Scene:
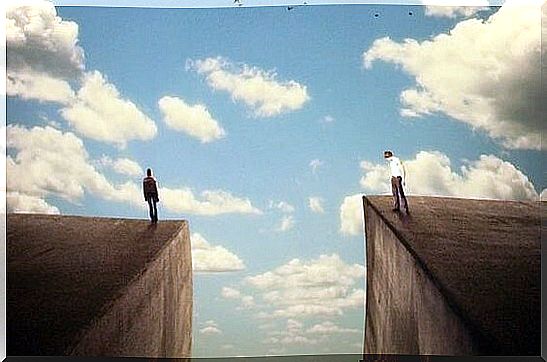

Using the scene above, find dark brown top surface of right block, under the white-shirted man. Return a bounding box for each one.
[363,196,547,354]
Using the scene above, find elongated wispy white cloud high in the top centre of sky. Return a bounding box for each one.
[187,57,310,117]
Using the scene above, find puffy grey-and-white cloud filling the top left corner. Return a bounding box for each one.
[6,0,84,103]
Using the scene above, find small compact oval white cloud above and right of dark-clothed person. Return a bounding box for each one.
[158,96,226,143]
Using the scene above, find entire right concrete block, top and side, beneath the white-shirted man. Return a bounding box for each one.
[363,196,545,355]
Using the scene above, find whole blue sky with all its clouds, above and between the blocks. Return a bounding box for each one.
[5,0,547,357]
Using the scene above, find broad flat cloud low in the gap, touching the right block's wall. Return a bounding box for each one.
[246,254,365,318]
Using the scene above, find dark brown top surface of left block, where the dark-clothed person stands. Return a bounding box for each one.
[6,214,190,355]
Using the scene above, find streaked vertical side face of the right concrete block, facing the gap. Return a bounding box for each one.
[364,202,478,355]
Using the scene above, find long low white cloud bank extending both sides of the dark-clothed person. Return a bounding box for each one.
[6,125,261,216]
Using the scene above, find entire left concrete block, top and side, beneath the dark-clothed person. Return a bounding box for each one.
[7,214,192,357]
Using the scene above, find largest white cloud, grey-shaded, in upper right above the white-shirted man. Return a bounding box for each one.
[363,3,547,149]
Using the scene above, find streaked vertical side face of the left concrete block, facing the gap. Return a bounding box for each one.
[66,223,193,358]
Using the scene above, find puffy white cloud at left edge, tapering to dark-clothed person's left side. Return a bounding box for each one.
[6,125,142,212]
